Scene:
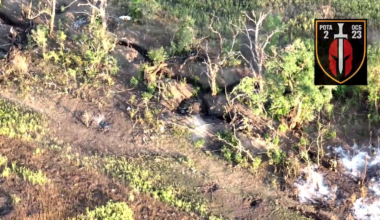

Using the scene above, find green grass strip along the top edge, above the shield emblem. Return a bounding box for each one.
[127,0,380,42]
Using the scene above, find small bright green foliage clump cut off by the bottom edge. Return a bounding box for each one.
[74,201,133,220]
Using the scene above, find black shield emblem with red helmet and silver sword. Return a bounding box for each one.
[315,19,367,85]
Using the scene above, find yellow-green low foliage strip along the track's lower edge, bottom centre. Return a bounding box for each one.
[92,157,207,215]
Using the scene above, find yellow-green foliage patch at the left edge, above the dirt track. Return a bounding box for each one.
[0,99,46,140]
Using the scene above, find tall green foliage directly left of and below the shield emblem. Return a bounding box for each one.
[266,39,336,121]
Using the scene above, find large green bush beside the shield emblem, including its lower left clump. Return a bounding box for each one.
[232,39,336,124]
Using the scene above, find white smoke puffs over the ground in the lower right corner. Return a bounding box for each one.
[295,145,380,220]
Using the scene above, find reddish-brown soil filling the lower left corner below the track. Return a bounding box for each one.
[0,136,196,219]
